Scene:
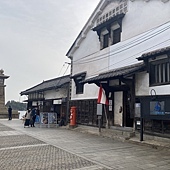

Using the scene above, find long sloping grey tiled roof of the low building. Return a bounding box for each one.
[21,75,70,95]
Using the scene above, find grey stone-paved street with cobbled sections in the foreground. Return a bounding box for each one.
[0,120,170,170]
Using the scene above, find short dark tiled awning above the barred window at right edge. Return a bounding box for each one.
[137,46,170,60]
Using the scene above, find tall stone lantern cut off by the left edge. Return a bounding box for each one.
[0,69,9,118]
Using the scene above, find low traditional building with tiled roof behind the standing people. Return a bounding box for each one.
[20,75,70,122]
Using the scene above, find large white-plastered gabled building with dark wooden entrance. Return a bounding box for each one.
[67,0,170,131]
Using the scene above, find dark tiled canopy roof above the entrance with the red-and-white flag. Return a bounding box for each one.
[81,63,145,83]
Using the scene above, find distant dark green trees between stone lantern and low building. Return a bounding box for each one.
[5,100,27,111]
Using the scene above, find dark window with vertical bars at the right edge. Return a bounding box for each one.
[149,59,170,85]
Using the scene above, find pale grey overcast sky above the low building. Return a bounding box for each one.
[0,0,99,102]
